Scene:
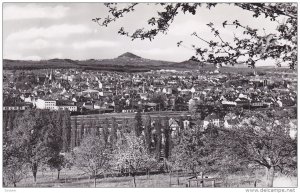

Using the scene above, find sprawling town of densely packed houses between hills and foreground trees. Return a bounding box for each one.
[3,63,297,146]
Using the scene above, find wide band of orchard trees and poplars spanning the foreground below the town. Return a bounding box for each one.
[3,110,297,187]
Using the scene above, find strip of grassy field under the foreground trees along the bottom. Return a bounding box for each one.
[10,168,297,188]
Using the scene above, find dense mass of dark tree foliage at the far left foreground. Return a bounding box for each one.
[3,110,70,183]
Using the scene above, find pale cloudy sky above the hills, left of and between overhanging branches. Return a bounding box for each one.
[3,3,276,62]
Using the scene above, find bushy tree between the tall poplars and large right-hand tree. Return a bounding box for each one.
[170,127,223,174]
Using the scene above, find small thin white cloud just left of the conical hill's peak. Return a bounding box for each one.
[72,40,119,49]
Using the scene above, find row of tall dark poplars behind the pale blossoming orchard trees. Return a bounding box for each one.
[71,111,180,160]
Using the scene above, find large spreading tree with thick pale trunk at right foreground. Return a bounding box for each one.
[223,111,297,187]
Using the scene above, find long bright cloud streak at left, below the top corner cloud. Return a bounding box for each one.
[7,24,92,41]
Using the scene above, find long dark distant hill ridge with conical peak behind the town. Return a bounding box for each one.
[3,52,272,72]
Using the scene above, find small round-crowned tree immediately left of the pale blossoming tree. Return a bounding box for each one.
[74,135,111,187]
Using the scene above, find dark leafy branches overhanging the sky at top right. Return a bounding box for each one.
[92,3,298,69]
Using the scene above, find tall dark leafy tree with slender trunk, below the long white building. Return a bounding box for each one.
[11,110,54,182]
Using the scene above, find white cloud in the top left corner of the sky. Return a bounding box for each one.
[3,4,70,20]
